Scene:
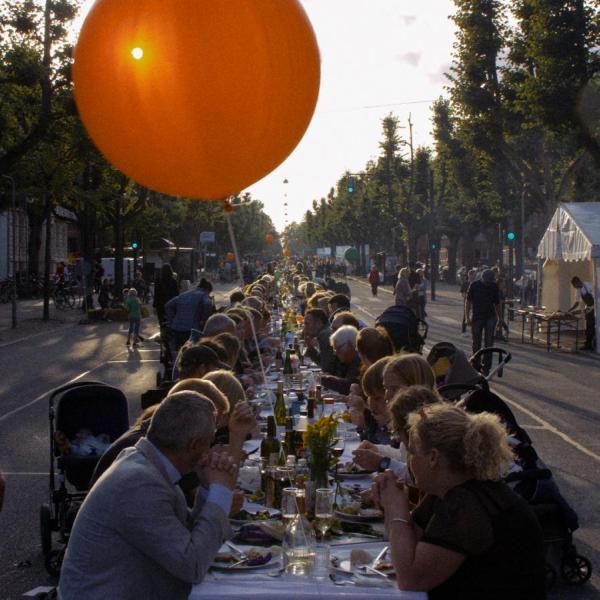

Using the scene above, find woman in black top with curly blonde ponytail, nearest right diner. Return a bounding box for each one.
[374,403,546,600]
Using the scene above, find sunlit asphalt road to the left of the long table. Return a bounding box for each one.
[0,292,232,600]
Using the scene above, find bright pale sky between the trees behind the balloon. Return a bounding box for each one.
[77,0,455,231]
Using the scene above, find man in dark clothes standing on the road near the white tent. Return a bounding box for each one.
[465,269,502,375]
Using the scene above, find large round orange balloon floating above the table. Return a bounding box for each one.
[73,0,320,199]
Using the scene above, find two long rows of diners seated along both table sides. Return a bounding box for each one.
[59,262,546,600]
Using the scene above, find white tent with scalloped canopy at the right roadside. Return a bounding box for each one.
[537,202,600,352]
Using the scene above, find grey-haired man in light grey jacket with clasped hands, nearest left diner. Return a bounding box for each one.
[58,392,237,600]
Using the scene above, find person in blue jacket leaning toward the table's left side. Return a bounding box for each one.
[165,278,214,351]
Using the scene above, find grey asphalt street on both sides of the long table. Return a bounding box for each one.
[0,282,600,600]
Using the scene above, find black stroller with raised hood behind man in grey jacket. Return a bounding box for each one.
[40,381,129,577]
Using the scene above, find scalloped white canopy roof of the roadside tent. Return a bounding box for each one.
[537,202,600,261]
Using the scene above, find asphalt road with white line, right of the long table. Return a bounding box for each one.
[351,281,600,600]
